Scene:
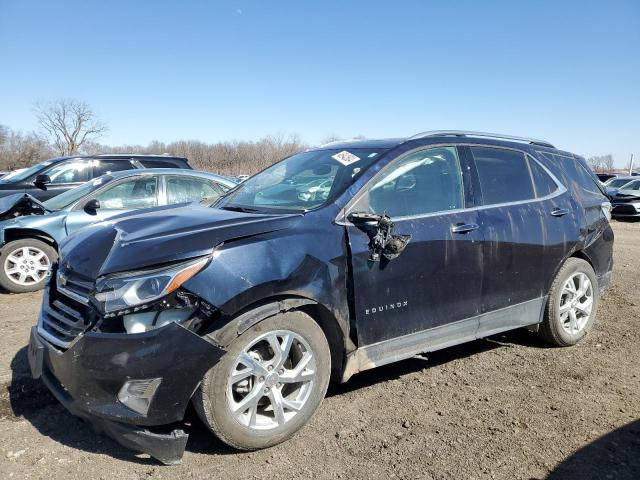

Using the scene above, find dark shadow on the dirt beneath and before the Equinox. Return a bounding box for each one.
[5,332,543,465]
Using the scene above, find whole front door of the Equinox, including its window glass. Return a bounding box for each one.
[346,147,482,346]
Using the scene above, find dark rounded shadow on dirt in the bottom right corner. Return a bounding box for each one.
[547,420,640,480]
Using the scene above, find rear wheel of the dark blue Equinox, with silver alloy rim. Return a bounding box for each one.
[538,257,599,347]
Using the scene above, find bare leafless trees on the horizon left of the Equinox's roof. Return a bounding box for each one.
[0,99,307,175]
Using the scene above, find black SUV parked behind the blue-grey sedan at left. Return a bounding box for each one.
[0,154,191,201]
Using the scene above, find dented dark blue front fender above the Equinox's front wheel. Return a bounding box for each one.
[183,226,349,338]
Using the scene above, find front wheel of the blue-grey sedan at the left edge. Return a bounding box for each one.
[0,238,58,293]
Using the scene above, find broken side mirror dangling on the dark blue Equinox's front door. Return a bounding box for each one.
[347,212,411,262]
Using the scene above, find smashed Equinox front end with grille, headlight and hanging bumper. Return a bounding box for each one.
[29,258,224,464]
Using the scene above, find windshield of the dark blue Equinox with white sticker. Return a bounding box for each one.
[215,148,387,212]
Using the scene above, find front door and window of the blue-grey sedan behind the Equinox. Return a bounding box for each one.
[66,175,159,235]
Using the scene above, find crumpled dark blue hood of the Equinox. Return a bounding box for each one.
[60,204,301,280]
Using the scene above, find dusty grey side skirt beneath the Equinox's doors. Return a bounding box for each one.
[342,296,547,382]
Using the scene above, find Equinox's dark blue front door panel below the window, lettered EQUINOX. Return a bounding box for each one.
[347,211,482,346]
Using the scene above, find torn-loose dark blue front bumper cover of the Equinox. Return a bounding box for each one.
[29,323,224,464]
